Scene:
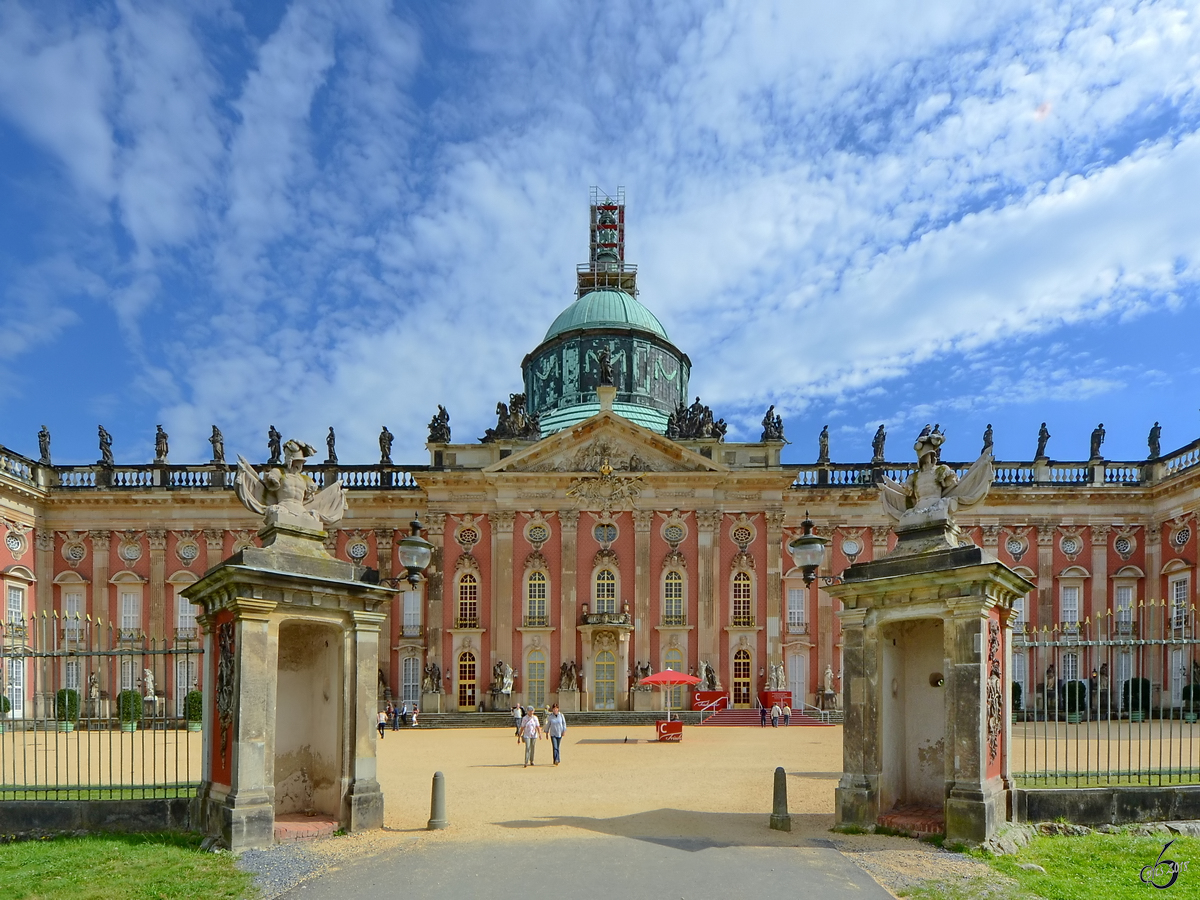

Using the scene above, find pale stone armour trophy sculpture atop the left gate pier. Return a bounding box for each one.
[234,440,346,532]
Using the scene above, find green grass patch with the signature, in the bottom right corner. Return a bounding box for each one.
[906,833,1200,900]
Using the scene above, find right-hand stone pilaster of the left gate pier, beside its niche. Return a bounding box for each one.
[342,610,385,832]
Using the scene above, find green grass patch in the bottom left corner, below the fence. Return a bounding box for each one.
[0,834,257,900]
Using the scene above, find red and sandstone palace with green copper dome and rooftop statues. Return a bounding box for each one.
[0,192,1200,718]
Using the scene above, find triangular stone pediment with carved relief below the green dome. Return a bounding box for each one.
[484,409,730,474]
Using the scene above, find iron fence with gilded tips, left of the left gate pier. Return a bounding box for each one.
[0,612,203,800]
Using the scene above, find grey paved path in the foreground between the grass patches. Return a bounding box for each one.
[283,836,893,900]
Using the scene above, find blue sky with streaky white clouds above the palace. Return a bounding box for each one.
[0,0,1200,463]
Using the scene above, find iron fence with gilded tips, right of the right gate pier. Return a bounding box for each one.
[1012,601,1200,787]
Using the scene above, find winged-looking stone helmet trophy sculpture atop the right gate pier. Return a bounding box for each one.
[880,425,995,533]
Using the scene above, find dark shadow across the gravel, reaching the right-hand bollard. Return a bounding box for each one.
[496,809,833,852]
